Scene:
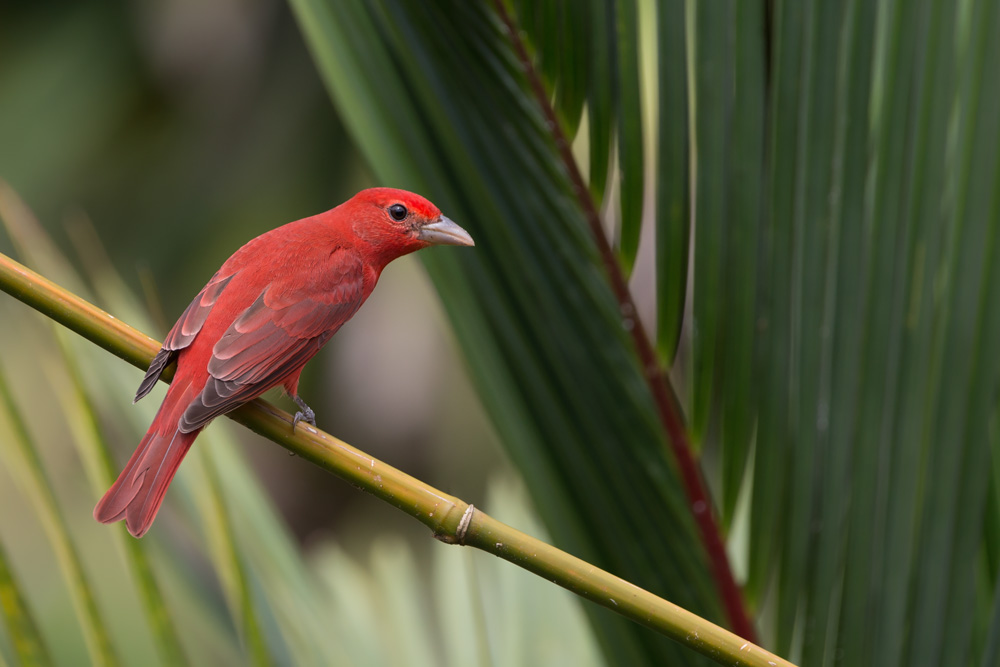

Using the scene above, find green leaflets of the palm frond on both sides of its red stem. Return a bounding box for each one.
[293,0,1000,664]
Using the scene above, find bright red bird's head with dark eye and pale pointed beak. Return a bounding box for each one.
[338,188,475,263]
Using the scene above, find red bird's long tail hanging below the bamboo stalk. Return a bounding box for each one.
[94,381,201,537]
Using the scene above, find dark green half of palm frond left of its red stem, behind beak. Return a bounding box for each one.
[295,2,736,664]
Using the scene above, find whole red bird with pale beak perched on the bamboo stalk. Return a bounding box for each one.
[94,188,474,537]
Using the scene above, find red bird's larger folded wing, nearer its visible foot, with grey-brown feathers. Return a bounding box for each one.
[178,250,364,432]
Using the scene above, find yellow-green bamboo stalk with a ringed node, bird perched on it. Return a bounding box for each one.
[0,254,792,667]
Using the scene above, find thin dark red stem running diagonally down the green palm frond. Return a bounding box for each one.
[493,0,757,643]
